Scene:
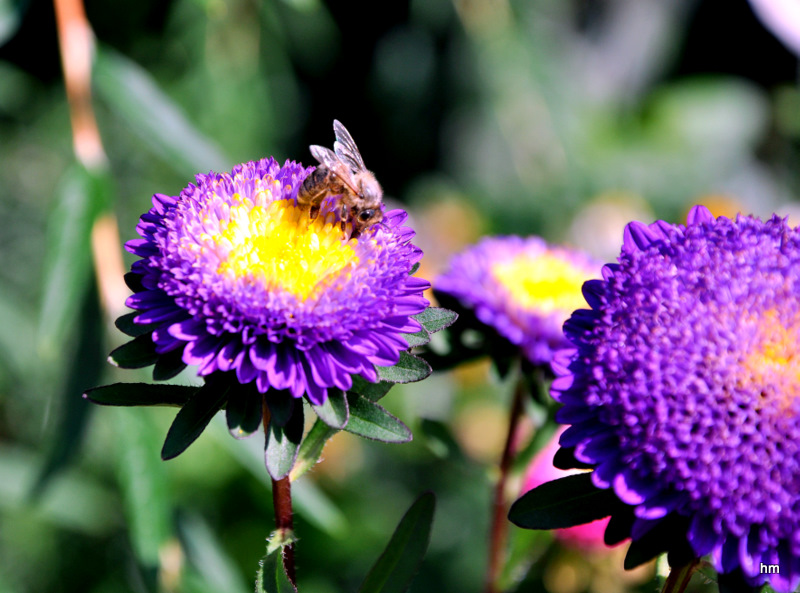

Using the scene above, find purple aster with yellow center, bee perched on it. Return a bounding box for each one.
[126,158,430,404]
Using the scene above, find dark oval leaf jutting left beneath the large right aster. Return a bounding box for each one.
[508,473,620,529]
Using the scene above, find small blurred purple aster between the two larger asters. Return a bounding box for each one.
[435,236,600,364]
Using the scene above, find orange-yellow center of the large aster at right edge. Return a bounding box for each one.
[743,310,800,411]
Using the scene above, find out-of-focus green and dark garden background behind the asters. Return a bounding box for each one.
[0,0,800,593]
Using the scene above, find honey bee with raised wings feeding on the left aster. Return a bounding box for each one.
[297,120,383,238]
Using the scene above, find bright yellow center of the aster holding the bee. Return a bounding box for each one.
[211,200,358,300]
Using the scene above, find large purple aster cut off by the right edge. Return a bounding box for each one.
[552,206,800,591]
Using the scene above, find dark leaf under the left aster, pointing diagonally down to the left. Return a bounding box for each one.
[161,377,228,460]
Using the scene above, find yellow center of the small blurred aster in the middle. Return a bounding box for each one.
[492,253,589,313]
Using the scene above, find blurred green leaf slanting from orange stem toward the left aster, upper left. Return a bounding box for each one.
[93,46,229,174]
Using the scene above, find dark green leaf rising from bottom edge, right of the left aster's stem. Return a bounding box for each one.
[358,492,436,593]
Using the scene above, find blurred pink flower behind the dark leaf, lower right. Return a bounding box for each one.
[520,427,609,551]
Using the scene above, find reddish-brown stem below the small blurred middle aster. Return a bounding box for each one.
[485,370,526,593]
